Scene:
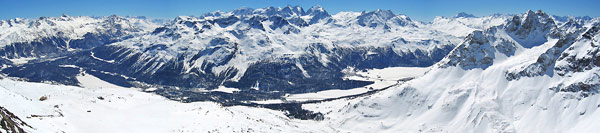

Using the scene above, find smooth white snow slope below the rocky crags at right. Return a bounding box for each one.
[303,67,600,132]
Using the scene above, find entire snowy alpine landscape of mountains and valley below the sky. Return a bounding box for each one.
[0,6,600,132]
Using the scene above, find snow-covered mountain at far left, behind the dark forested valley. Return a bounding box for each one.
[0,14,158,65]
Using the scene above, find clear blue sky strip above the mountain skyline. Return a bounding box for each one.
[0,0,600,21]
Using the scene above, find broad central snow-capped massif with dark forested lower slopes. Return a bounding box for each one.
[3,6,468,103]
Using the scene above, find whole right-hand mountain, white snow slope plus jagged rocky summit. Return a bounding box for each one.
[304,11,600,132]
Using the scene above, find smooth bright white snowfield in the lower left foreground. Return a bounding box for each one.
[0,79,328,132]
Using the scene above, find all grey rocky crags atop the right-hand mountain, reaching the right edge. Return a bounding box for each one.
[437,11,600,97]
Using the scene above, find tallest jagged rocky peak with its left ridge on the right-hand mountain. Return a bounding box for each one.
[440,10,560,69]
